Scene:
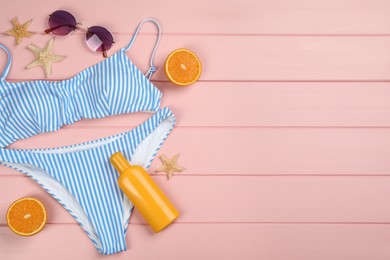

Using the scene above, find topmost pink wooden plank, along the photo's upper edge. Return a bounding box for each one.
[0,0,390,34]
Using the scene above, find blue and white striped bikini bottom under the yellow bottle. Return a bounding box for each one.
[0,108,176,254]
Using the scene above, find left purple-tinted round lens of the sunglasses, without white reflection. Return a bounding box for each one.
[49,10,76,36]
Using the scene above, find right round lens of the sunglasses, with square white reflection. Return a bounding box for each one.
[85,26,114,52]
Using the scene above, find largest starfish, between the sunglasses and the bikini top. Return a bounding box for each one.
[26,38,65,77]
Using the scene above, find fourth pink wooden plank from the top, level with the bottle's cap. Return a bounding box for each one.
[1,127,390,175]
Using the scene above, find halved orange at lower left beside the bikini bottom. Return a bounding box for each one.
[7,198,46,236]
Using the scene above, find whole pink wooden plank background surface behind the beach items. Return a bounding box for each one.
[0,0,390,260]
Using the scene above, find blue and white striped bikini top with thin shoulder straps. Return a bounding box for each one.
[0,18,162,147]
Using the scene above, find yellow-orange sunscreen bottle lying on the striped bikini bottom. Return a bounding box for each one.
[110,152,180,232]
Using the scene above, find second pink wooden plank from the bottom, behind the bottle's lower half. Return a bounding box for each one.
[0,174,390,224]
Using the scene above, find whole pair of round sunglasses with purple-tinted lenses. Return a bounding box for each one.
[45,10,114,58]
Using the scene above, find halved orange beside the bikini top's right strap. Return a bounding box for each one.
[165,48,202,86]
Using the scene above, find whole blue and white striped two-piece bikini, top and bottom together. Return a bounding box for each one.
[0,18,175,254]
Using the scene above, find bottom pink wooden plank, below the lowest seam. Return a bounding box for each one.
[0,224,390,260]
